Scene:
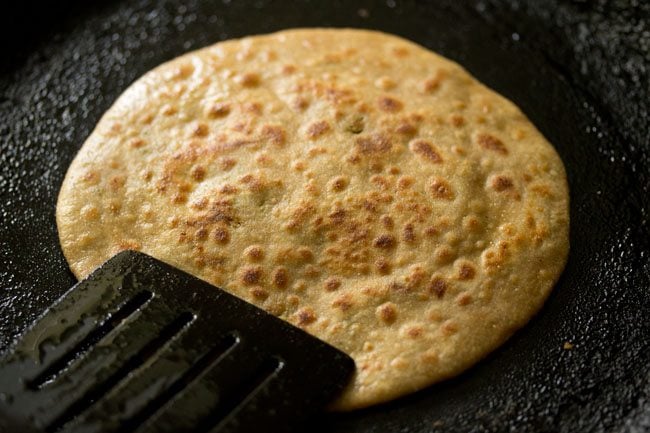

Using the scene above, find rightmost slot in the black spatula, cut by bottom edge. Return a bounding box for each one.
[196,357,284,433]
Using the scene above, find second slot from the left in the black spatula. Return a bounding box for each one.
[45,312,195,433]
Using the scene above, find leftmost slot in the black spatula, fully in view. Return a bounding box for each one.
[26,291,153,391]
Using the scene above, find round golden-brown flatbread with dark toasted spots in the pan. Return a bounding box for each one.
[57,29,569,410]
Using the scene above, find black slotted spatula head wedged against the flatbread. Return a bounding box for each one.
[0,251,354,433]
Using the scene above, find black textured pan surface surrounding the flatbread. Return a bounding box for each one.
[0,0,650,433]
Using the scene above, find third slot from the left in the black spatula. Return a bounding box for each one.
[121,332,240,432]
